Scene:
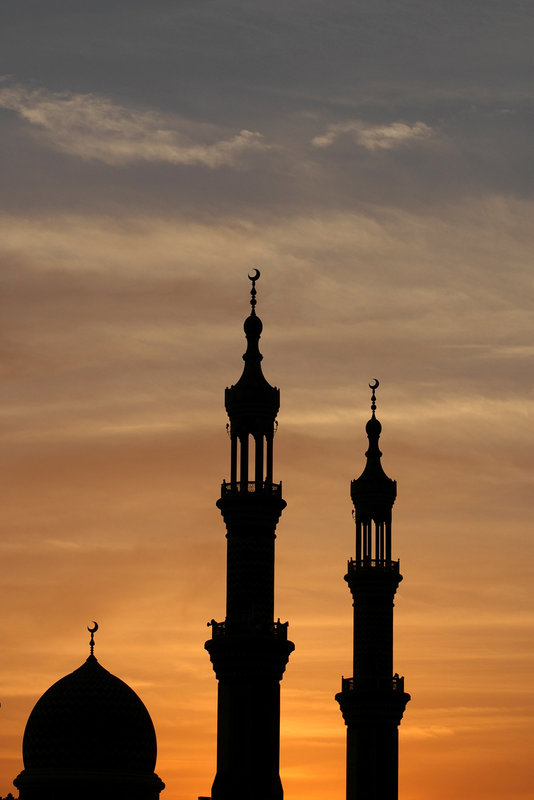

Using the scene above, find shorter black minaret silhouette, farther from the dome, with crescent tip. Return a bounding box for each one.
[336,379,410,800]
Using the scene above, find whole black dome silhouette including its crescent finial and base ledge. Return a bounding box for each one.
[13,626,165,800]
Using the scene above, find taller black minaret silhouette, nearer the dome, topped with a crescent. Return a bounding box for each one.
[206,270,294,800]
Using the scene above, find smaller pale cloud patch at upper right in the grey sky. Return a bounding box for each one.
[312,120,433,150]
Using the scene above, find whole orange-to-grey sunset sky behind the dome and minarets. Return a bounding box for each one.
[0,0,534,800]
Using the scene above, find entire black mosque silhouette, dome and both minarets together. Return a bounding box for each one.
[0,270,410,800]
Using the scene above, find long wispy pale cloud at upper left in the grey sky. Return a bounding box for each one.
[0,85,267,169]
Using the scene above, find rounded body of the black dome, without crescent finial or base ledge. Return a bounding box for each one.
[22,655,157,774]
